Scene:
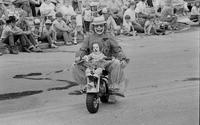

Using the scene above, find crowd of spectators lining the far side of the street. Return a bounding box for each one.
[0,0,200,54]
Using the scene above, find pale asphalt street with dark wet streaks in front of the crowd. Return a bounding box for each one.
[0,27,200,125]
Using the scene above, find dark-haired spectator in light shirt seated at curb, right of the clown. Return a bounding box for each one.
[123,15,136,36]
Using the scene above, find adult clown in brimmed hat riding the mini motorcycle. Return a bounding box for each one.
[72,16,128,102]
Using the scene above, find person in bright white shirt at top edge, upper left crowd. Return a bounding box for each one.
[40,0,55,19]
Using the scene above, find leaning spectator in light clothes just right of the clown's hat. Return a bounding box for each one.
[102,8,121,35]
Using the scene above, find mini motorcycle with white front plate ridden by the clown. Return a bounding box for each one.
[75,58,121,113]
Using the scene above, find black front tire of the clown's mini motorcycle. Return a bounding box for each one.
[86,94,99,113]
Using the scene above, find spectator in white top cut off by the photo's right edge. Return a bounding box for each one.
[190,1,200,23]
